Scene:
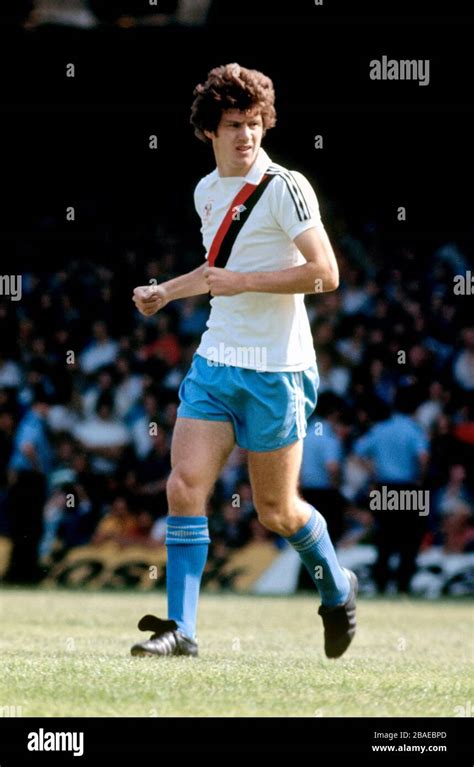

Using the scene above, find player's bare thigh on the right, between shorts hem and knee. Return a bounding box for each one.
[248,439,303,508]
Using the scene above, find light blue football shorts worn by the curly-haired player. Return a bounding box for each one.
[178,354,319,452]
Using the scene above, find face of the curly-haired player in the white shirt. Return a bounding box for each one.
[205,109,263,176]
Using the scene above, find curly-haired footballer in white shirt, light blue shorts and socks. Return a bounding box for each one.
[131,63,357,658]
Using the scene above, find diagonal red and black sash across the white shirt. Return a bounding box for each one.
[207,173,275,268]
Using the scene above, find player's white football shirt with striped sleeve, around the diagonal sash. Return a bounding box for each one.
[194,148,323,372]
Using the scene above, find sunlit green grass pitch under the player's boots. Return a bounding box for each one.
[0,589,473,717]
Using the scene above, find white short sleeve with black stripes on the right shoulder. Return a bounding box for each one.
[271,170,322,240]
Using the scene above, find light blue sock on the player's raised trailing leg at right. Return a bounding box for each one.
[286,506,350,607]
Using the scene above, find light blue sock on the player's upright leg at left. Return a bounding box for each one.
[166,517,211,639]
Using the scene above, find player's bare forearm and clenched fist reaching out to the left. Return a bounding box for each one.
[133,262,209,317]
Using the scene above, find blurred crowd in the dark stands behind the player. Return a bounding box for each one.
[0,234,474,590]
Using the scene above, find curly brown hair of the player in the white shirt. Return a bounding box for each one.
[191,64,276,144]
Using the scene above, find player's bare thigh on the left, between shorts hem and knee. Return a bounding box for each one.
[171,418,235,494]
